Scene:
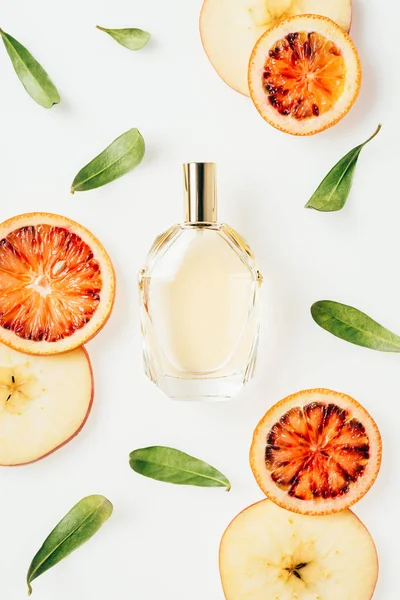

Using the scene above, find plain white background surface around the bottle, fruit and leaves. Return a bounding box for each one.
[0,0,400,600]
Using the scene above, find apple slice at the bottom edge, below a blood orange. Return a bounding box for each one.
[220,500,378,600]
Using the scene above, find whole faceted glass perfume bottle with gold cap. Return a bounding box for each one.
[139,163,262,400]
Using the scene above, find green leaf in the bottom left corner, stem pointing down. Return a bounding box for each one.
[26,495,113,595]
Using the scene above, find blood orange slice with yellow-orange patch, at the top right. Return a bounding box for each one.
[249,15,361,135]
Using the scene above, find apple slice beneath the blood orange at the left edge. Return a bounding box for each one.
[0,344,93,466]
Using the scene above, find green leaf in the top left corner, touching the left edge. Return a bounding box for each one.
[0,29,60,108]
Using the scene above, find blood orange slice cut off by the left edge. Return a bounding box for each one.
[0,213,115,354]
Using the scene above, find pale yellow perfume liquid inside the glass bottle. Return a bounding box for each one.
[150,228,254,374]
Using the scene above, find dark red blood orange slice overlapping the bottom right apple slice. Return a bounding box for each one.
[250,389,382,515]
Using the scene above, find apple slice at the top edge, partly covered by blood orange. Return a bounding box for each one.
[200,0,351,96]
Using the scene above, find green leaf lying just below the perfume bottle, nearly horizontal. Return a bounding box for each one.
[129,446,231,491]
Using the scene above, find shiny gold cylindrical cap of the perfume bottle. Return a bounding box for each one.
[183,163,217,223]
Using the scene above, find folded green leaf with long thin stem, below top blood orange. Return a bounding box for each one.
[305,125,382,212]
